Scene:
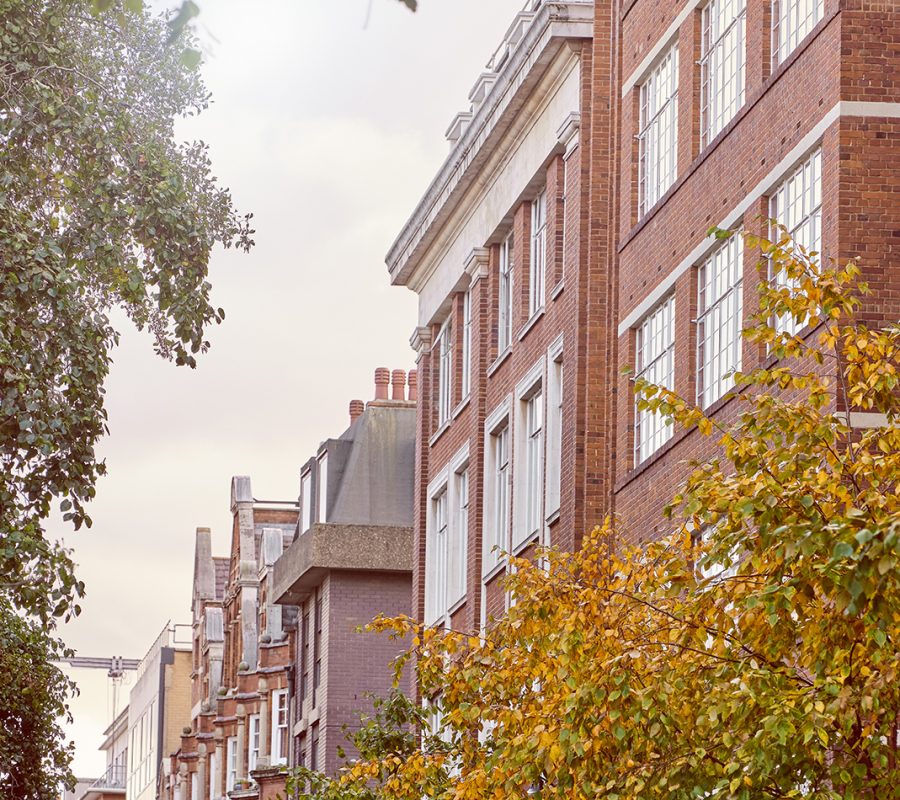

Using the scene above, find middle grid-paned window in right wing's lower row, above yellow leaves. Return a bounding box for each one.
[697,236,744,408]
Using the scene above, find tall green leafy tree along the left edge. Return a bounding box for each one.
[0,0,253,800]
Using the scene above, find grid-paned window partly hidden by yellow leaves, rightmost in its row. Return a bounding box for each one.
[769,149,822,334]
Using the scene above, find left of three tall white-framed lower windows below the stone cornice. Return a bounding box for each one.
[481,397,512,577]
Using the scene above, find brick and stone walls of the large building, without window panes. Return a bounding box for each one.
[387,0,900,631]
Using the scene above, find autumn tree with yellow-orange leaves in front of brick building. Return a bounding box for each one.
[306,232,900,800]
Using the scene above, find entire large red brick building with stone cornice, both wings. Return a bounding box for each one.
[387,0,900,630]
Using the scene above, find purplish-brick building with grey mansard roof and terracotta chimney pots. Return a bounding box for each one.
[270,368,416,775]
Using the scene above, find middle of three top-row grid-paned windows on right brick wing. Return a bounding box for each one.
[700,0,747,145]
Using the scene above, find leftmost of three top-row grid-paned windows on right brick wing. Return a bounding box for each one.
[638,42,678,216]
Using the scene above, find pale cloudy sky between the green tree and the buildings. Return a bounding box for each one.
[59,0,523,776]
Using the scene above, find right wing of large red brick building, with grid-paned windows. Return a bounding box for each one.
[611,0,900,540]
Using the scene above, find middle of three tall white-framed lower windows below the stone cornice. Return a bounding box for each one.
[512,356,545,553]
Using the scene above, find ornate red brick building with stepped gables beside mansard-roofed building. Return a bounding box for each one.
[163,476,299,800]
